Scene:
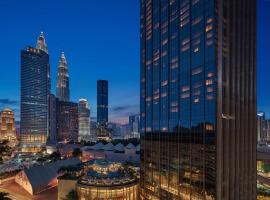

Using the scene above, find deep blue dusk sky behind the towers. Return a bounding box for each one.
[0,0,270,122]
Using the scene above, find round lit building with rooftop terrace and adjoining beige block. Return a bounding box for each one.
[58,160,139,200]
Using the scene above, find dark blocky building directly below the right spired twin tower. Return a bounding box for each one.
[56,100,79,141]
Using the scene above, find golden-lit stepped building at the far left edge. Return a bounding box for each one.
[0,108,17,146]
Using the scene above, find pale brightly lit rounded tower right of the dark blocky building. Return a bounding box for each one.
[78,99,91,141]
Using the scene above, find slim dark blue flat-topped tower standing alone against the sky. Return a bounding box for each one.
[97,80,108,124]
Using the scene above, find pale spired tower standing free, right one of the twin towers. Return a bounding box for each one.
[56,52,70,101]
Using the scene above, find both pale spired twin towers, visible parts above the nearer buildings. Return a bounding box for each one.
[36,32,70,101]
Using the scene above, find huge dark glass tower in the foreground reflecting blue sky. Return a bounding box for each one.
[140,0,257,200]
